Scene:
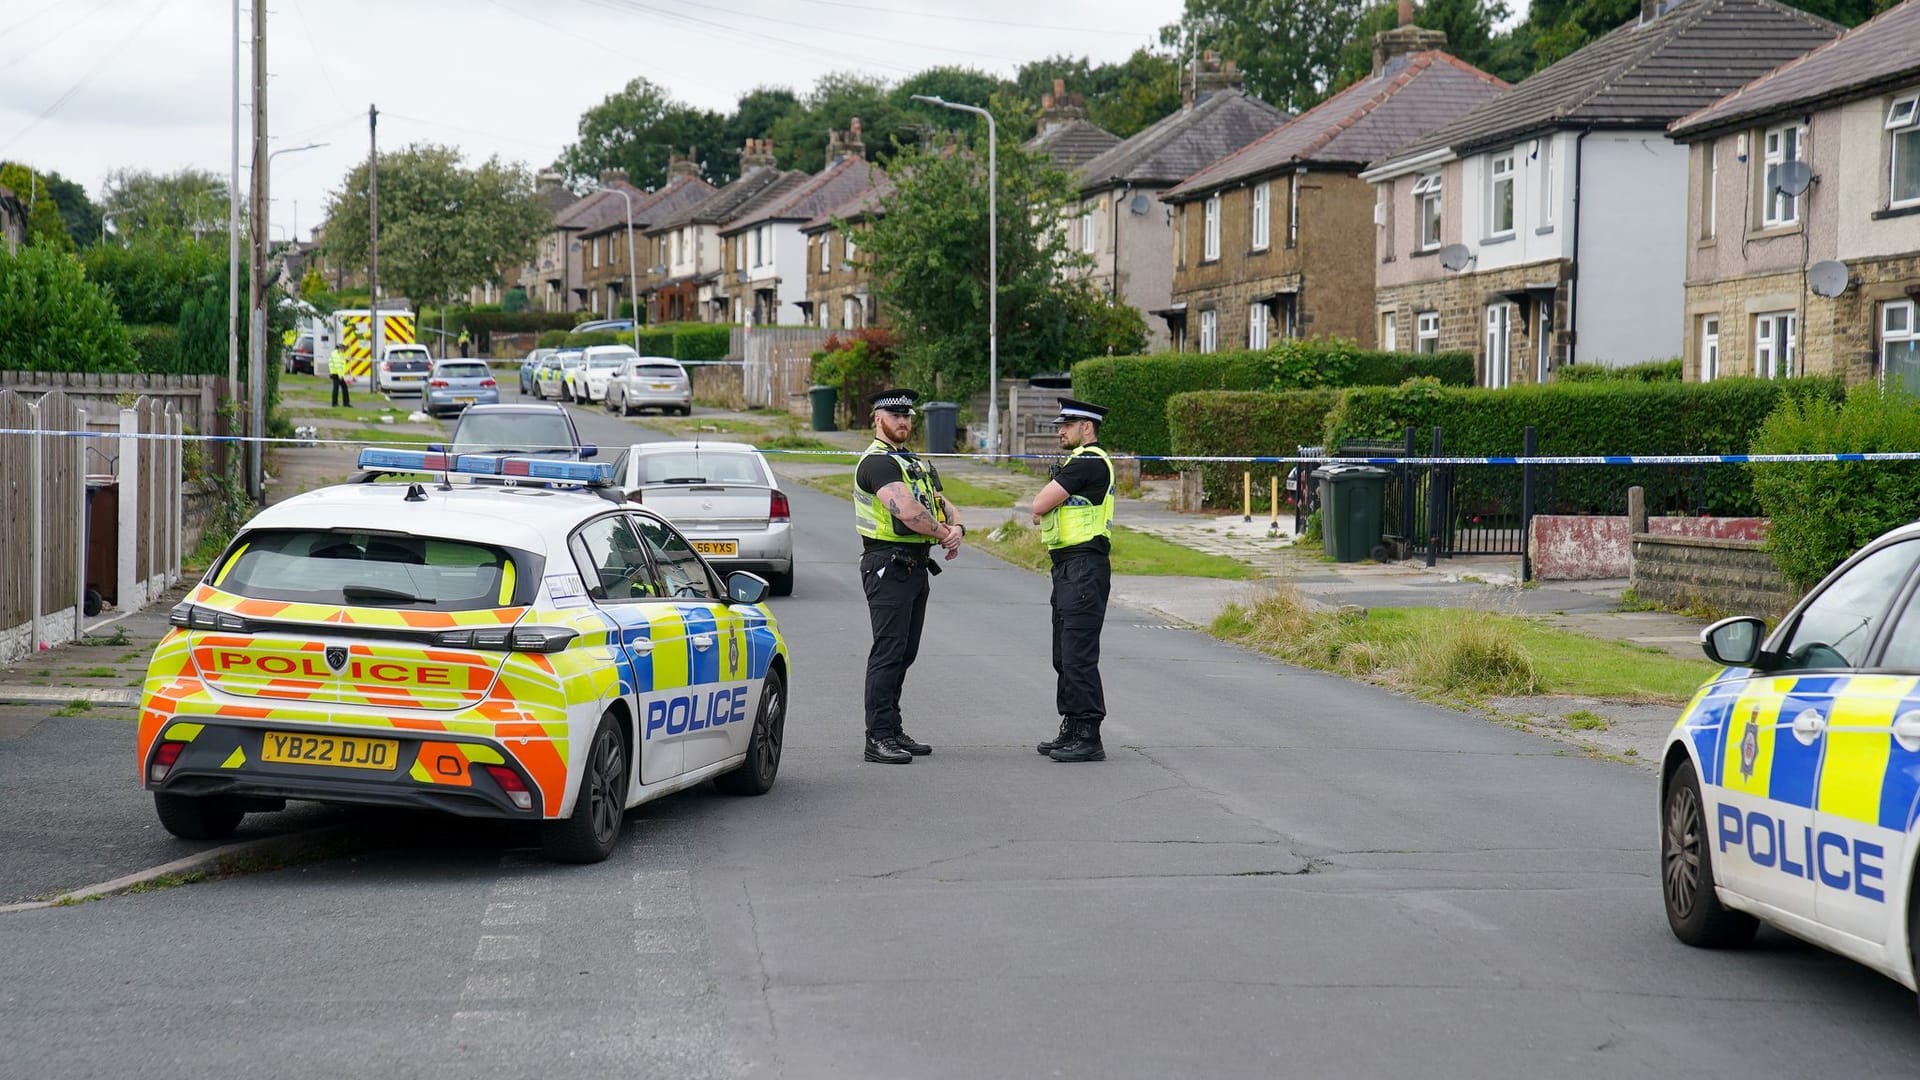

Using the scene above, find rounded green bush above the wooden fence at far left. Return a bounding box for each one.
[0,244,136,371]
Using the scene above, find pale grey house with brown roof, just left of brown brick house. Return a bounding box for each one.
[1064,54,1292,348]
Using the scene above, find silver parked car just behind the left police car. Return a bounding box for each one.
[612,442,793,596]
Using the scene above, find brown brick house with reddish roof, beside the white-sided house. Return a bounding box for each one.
[1160,14,1507,352]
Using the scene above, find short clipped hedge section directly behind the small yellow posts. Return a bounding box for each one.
[1167,386,1342,507]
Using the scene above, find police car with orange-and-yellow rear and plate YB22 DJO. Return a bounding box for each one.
[138,450,789,863]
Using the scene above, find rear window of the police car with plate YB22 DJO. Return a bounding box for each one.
[213,528,515,611]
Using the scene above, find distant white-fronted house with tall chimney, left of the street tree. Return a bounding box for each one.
[720,117,883,327]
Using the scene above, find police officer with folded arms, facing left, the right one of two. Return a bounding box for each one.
[1033,398,1114,761]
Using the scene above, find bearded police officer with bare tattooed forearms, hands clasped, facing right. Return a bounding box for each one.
[852,390,966,765]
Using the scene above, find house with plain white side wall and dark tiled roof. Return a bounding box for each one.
[1361,0,1837,386]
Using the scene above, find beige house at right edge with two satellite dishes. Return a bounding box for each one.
[1672,2,1920,384]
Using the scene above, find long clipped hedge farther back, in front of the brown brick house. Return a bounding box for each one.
[1073,338,1473,455]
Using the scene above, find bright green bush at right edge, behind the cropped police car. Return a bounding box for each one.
[1747,384,1920,590]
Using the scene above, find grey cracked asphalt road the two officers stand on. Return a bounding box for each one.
[0,397,1920,1080]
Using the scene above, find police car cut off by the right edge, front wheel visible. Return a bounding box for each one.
[1661,523,1920,988]
